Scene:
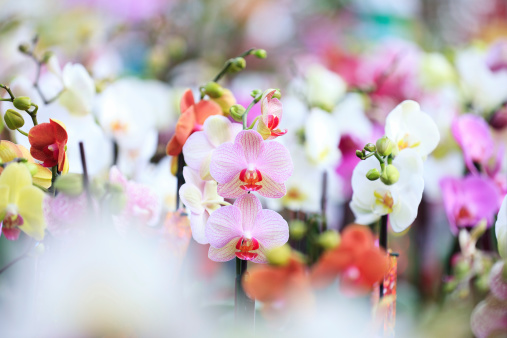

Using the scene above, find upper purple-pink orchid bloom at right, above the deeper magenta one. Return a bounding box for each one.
[451,114,494,173]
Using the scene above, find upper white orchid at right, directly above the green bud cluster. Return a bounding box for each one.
[385,100,440,158]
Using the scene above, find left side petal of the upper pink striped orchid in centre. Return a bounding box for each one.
[210,143,247,184]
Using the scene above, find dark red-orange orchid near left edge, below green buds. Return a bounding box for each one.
[28,119,68,172]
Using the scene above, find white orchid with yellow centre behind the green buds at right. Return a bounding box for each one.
[350,149,424,232]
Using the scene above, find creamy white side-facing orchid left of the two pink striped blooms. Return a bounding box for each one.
[179,167,225,244]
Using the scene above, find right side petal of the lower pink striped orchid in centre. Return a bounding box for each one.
[252,209,289,250]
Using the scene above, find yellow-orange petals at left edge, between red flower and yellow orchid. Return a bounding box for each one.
[0,141,51,189]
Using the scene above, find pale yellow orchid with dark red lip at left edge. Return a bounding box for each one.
[0,163,46,241]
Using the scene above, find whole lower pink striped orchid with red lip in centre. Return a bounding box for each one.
[206,194,289,263]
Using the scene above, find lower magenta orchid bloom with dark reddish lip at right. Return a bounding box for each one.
[440,175,500,234]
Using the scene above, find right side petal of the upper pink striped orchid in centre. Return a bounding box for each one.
[257,142,294,183]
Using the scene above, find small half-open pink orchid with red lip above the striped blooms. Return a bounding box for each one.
[257,89,287,140]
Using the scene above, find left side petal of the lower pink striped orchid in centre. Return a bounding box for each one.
[206,205,243,248]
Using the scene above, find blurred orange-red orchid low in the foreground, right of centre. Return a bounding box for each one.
[311,224,389,293]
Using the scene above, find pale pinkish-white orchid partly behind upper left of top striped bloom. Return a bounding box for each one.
[183,115,242,180]
